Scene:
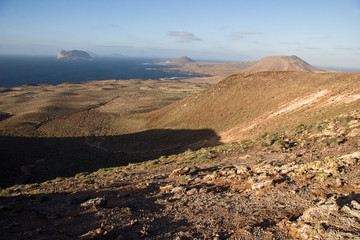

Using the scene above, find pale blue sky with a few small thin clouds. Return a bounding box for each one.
[0,0,360,69]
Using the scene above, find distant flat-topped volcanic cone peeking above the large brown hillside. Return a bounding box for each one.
[243,56,322,72]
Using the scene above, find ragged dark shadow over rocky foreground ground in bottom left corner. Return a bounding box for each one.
[0,181,184,239]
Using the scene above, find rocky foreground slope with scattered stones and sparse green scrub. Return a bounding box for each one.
[0,111,360,239]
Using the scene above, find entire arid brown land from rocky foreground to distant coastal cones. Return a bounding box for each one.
[0,56,360,239]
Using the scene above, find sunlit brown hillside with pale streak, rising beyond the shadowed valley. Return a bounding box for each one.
[145,72,360,142]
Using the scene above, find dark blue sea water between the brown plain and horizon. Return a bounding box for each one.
[0,56,201,87]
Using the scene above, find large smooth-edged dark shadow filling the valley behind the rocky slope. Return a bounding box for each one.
[0,129,220,187]
